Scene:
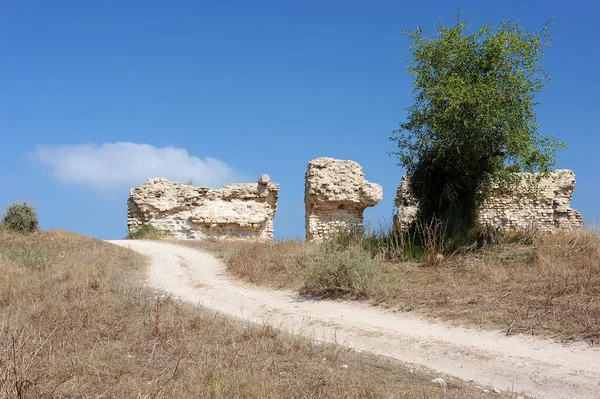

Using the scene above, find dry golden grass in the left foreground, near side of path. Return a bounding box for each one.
[0,231,516,398]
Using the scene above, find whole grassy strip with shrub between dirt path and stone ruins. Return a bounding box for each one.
[191,229,600,344]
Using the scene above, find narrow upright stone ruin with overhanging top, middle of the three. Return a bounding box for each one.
[304,158,383,242]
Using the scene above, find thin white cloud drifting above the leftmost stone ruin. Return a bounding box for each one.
[32,142,244,191]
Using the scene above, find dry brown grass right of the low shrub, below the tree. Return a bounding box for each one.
[380,230,600,344]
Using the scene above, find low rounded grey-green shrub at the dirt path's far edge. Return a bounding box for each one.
[300,242,380,298]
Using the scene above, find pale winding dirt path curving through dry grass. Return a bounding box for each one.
[111,241,600,399]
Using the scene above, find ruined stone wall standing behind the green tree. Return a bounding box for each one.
[394,169,582,231]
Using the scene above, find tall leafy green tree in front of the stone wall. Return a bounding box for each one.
[390,15,564,239]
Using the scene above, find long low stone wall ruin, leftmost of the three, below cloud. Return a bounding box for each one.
[127,175,279,239]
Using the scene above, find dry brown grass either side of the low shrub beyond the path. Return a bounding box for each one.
[196,229,600,344]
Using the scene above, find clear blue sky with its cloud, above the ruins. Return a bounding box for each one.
[0,0,600,238]
